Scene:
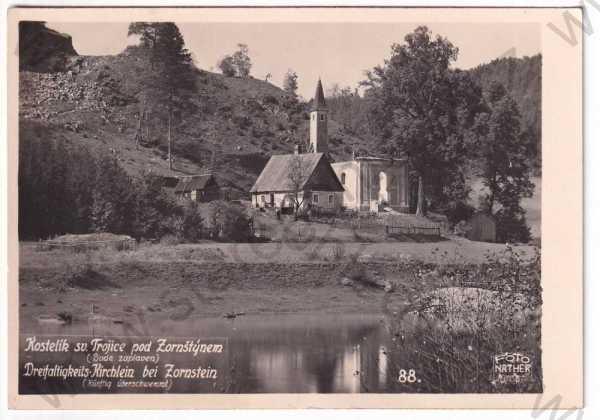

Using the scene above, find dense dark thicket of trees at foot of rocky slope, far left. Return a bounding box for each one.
[18,126,211,242]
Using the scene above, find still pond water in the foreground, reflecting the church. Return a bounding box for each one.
[20,314,398,393]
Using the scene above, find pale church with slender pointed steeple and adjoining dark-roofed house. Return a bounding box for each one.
[250,80,409,212]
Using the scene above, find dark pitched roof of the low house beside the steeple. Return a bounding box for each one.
[250,153,344,192]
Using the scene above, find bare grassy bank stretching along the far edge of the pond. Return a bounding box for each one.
[19,241,533,332]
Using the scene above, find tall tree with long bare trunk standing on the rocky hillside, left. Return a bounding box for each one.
[128,22,195,169]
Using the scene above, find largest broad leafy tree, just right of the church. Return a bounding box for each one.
[362,26,481,215]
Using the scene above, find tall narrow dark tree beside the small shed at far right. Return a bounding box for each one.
[473,83,535,241]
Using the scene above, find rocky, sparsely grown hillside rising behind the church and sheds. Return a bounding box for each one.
[19,43,364,194]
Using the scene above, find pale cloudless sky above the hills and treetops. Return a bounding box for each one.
[47,22,541,99]
